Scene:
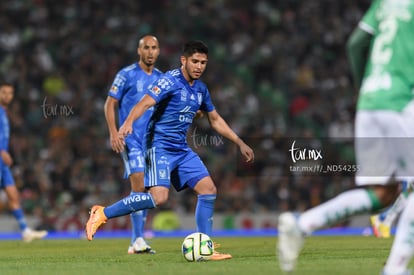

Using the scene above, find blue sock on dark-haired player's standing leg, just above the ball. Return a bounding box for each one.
[195,195,216,236]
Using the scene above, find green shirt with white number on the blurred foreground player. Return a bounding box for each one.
[357,0,414,111]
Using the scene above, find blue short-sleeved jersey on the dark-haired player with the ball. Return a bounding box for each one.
[146,69,215,149]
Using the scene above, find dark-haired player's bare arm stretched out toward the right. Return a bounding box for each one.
[207,110,254,162]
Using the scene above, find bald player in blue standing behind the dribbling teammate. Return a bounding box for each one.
[104,35,162,254]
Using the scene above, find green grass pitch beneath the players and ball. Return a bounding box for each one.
[0,236,408,275]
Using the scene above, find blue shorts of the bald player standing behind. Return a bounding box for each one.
[121,135,145,179]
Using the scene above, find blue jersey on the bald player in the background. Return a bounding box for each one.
[108,63,162,140]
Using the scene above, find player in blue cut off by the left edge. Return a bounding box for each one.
[0,83,47,242]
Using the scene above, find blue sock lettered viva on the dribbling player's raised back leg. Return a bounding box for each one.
[104,192,156,219]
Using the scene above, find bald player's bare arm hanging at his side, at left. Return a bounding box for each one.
[104,96,124,153]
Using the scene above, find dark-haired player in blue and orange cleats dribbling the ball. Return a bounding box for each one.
[86,40,254,260]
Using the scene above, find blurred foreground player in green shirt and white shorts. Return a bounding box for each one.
[278,0,414,274]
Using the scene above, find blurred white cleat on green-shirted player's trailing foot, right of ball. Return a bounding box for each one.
[277,212,304,272]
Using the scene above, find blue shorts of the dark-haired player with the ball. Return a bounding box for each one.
[144,147,210,191]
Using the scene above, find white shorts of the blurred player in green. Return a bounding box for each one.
[355,101,414,185]
